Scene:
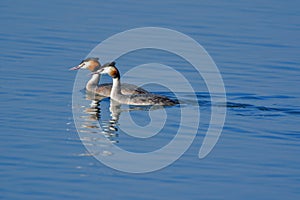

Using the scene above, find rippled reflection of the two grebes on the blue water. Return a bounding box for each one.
[74,93,170,156]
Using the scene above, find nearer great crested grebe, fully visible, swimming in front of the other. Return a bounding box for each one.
[93,62,179,106]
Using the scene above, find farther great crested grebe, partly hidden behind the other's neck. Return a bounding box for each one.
[70,58,148,97]
